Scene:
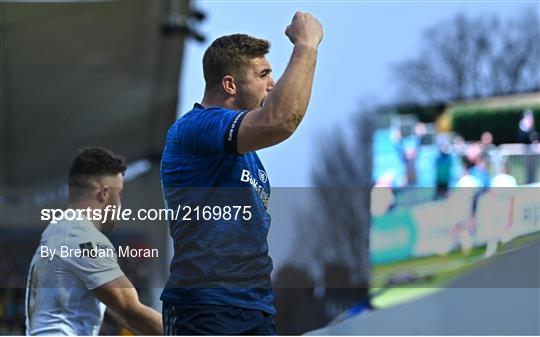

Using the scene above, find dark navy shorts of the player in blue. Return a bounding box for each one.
[163,302,277,336]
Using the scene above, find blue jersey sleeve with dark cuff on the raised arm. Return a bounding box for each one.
[177,108,247,154]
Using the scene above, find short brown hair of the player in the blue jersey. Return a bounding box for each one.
[203,34,270,88]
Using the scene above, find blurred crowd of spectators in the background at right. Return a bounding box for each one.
[372,109,540,215]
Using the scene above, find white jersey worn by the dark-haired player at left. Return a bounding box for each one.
[25,220,124,335]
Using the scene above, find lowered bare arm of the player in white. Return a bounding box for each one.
[92,276,163,335]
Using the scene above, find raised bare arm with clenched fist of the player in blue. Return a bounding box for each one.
[237,12,323,154]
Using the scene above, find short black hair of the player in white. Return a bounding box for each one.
[68,147,127,192]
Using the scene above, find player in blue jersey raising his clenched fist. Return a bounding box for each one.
[161,12,323,335]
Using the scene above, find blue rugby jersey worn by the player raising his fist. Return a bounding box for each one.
[161,104,275,314]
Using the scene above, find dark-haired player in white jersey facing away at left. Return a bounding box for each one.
[26,148,163,335]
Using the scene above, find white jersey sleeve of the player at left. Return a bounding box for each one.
[63,240,124,290]
